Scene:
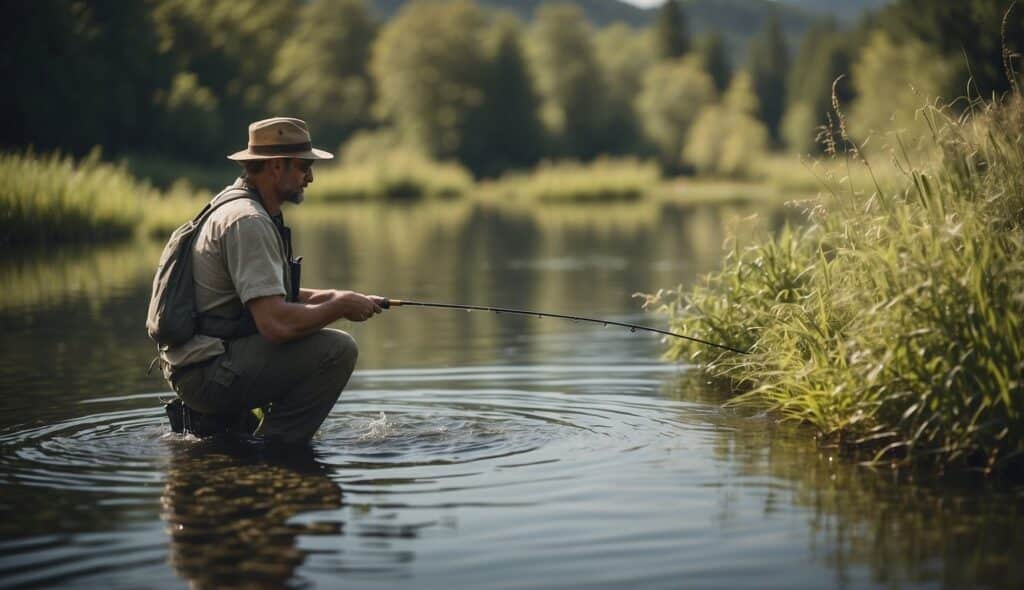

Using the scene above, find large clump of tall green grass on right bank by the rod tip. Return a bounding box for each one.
[647,96,1024,472]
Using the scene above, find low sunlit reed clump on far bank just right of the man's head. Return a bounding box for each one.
[306,150,473,201]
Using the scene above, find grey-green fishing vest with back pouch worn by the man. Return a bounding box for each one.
[145,186,302,347]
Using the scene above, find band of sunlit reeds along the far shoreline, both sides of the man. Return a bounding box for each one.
[0,150,814,247]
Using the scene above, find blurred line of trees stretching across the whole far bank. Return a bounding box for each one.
[0,0,1024,175]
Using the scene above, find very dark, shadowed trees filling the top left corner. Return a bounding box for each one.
[0,0,173,155]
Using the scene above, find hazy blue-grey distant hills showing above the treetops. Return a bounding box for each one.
[370,0,815,60]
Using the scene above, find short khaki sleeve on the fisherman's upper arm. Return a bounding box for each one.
[222,215,287,304]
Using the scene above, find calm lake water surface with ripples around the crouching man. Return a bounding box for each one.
[0,204,1024,588]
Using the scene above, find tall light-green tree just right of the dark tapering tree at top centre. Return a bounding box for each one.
[528,4,605,158]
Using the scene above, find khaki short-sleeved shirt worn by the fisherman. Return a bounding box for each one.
[160,179,288,368]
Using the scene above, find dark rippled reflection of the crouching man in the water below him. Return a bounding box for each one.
[161,440,342,588]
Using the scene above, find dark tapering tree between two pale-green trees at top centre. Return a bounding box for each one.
[470,15,544,174]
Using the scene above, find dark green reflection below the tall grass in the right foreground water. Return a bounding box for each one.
[666,373,1024,588]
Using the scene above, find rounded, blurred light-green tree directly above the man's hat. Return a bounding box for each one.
[270,0,377,144]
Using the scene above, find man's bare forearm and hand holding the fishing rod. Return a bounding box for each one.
[247,291,381,343]
